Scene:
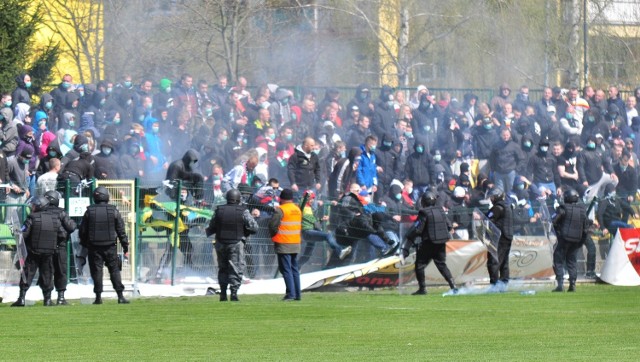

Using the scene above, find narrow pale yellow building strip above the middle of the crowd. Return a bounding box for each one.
[378,0,400,87]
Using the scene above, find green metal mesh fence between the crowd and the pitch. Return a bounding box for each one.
[0,180,609,285]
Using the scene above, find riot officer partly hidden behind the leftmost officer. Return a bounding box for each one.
[44,190,76,305]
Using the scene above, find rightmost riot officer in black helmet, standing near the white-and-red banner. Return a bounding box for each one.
[553,189,590,292]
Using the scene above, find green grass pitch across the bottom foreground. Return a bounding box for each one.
[0,285,640,361]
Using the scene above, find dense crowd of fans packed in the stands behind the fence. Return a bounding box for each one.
[0,74,640,264]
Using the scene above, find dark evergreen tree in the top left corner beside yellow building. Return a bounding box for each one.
[0,0,59,94]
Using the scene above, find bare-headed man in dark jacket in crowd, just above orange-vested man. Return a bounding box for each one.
[287,137,322,192]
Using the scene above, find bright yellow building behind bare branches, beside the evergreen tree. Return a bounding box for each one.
[32,0,104,84]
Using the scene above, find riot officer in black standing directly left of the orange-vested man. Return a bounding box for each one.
[206,189,258,302]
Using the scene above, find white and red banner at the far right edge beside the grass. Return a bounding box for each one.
[600,229,640,286]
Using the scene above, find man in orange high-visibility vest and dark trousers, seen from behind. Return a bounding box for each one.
[269,189,302,302]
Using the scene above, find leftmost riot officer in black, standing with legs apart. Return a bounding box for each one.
[11,196,75,307]
